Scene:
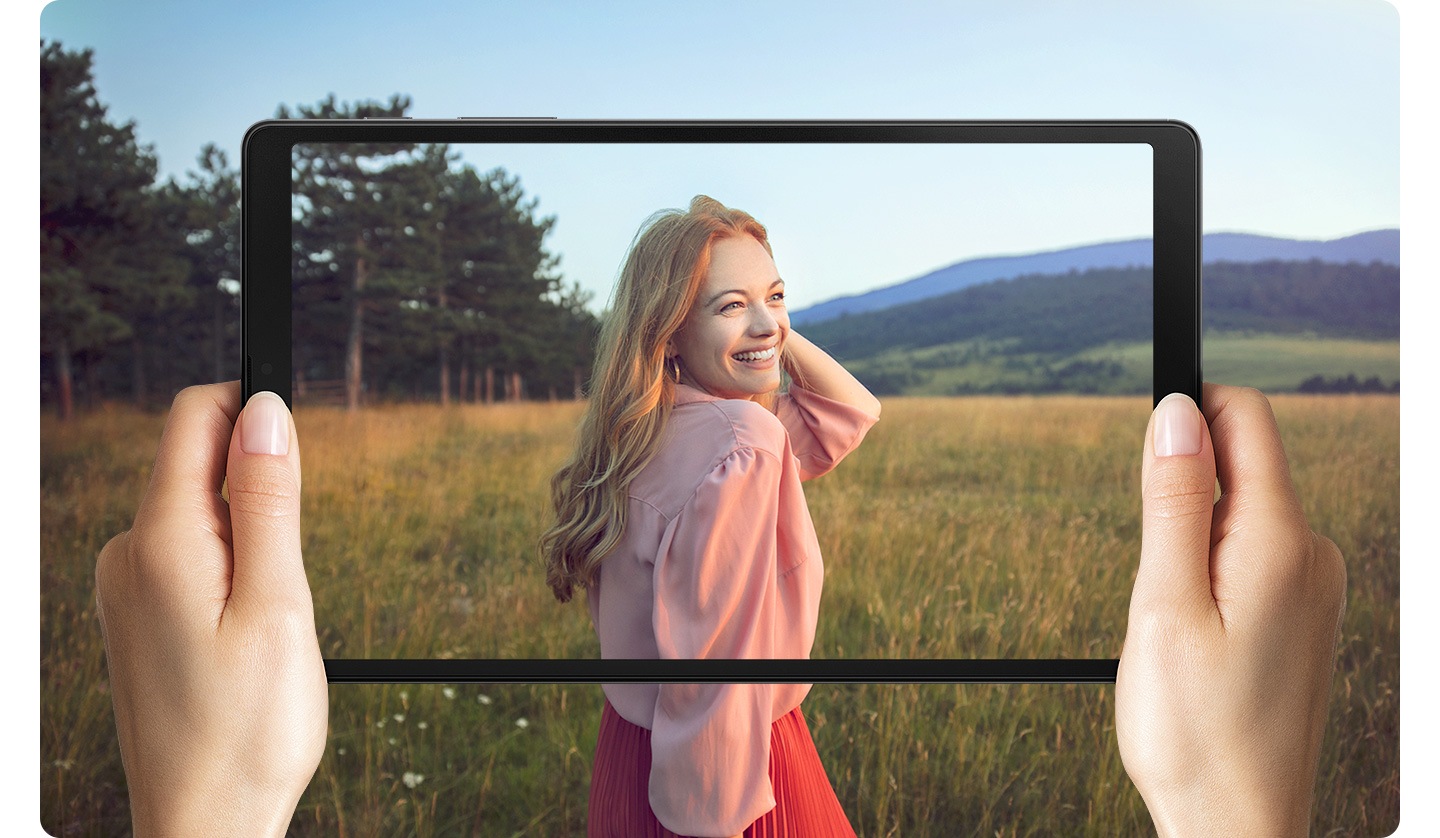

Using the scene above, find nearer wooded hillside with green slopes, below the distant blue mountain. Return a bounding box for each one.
[804,261,1400,395]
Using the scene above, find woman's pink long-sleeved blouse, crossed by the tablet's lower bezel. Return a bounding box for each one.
[588,386,876,835]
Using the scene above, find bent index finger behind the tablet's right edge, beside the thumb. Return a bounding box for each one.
[1205,384,1305,523]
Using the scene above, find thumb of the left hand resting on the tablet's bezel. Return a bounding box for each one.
[226,392,310,615]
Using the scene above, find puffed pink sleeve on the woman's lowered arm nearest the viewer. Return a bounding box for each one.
[649,448,782,835]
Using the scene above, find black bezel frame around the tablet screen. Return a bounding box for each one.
[240,120,1202,684]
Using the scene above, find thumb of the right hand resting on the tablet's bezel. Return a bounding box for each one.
[1130,393,1215,624]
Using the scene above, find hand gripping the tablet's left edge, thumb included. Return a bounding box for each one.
[95,382,328,838]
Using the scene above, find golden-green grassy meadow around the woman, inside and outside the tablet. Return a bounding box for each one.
[39,396,1400,837]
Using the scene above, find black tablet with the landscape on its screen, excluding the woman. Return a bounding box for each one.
[242,120,1201,682]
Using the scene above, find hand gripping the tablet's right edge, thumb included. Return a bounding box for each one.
[1115,384,1345,835]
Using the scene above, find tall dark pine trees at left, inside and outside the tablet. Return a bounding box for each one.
[40,42,598,416]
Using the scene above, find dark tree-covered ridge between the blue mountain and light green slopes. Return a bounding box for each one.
[806,261,1400,361]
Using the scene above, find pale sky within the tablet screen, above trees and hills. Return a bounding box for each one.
[283,144,1153,311]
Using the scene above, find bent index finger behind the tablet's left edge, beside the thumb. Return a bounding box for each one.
[135,382,240,526]
